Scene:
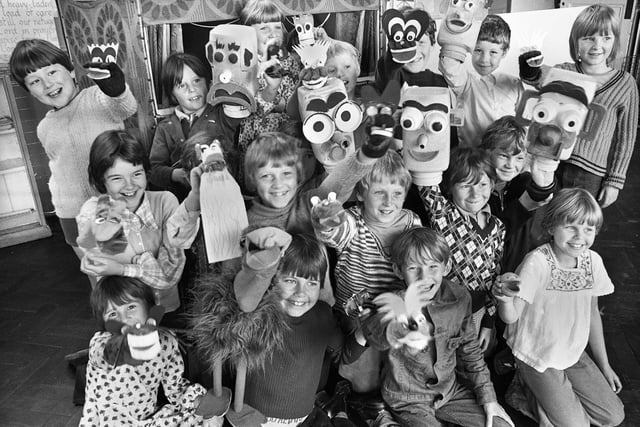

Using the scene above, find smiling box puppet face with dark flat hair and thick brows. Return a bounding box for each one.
[400,85,450,181]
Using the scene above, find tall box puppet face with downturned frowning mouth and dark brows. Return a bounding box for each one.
[206,24,258,117]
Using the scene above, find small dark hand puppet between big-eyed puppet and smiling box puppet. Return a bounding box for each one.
[360,103,396,159]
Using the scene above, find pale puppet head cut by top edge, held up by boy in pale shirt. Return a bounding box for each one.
[438,0,489,62]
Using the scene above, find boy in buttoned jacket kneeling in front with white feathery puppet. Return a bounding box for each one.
[362,227,513,426]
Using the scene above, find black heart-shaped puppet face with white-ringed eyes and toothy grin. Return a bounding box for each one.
[382,9,435,64]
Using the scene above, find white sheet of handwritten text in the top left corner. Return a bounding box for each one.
[0,0,60,64]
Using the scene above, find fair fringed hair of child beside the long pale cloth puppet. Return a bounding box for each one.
[244,132,304,191]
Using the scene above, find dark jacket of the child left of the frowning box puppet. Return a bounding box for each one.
[149,104,239,200]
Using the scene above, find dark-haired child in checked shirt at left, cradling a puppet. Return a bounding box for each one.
[77,131,185,312]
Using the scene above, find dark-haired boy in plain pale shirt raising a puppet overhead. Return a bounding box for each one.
[438,15,524,147]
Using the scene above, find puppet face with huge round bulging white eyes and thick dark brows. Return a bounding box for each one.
[298,78,362,146]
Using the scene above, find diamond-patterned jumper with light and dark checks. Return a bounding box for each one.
[420,185,505,327]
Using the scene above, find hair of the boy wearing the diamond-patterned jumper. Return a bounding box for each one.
[442,147,496,198]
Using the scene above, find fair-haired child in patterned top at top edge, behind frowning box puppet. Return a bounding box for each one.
[239,0,300,115]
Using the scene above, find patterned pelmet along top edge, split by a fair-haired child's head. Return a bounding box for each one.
[140,0,380,25]
